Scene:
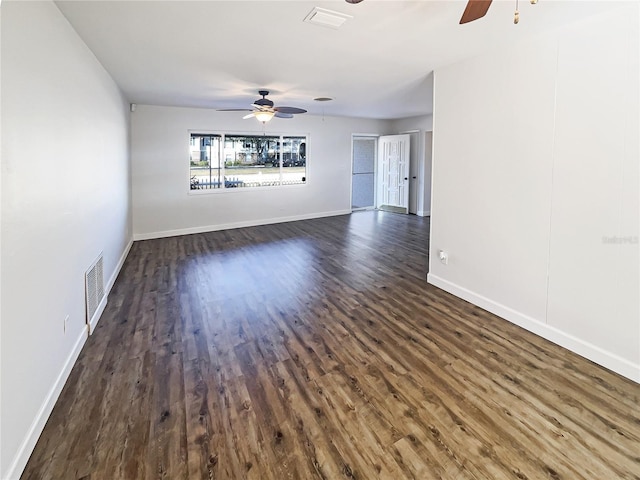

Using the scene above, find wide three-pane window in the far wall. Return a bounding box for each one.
[189,133,307,190]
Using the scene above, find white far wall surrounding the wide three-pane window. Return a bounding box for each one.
[131,105,388,239]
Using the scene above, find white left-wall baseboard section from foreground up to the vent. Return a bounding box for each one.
[2,328,87,480]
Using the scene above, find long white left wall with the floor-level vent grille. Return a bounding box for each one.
[0,1,132,479]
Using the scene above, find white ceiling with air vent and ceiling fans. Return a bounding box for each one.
[56,0,616,119]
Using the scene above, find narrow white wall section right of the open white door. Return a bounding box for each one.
[391,115,433,217]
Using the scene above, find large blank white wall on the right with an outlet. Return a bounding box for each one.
[429,2,640,381]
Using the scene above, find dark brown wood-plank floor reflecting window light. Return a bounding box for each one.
[22,212,640,480]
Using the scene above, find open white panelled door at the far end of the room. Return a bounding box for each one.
[377,135,410,213]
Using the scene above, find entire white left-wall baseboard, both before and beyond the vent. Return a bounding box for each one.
[0,239,133,480]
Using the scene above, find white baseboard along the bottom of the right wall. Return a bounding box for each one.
[427,273,640,383]
